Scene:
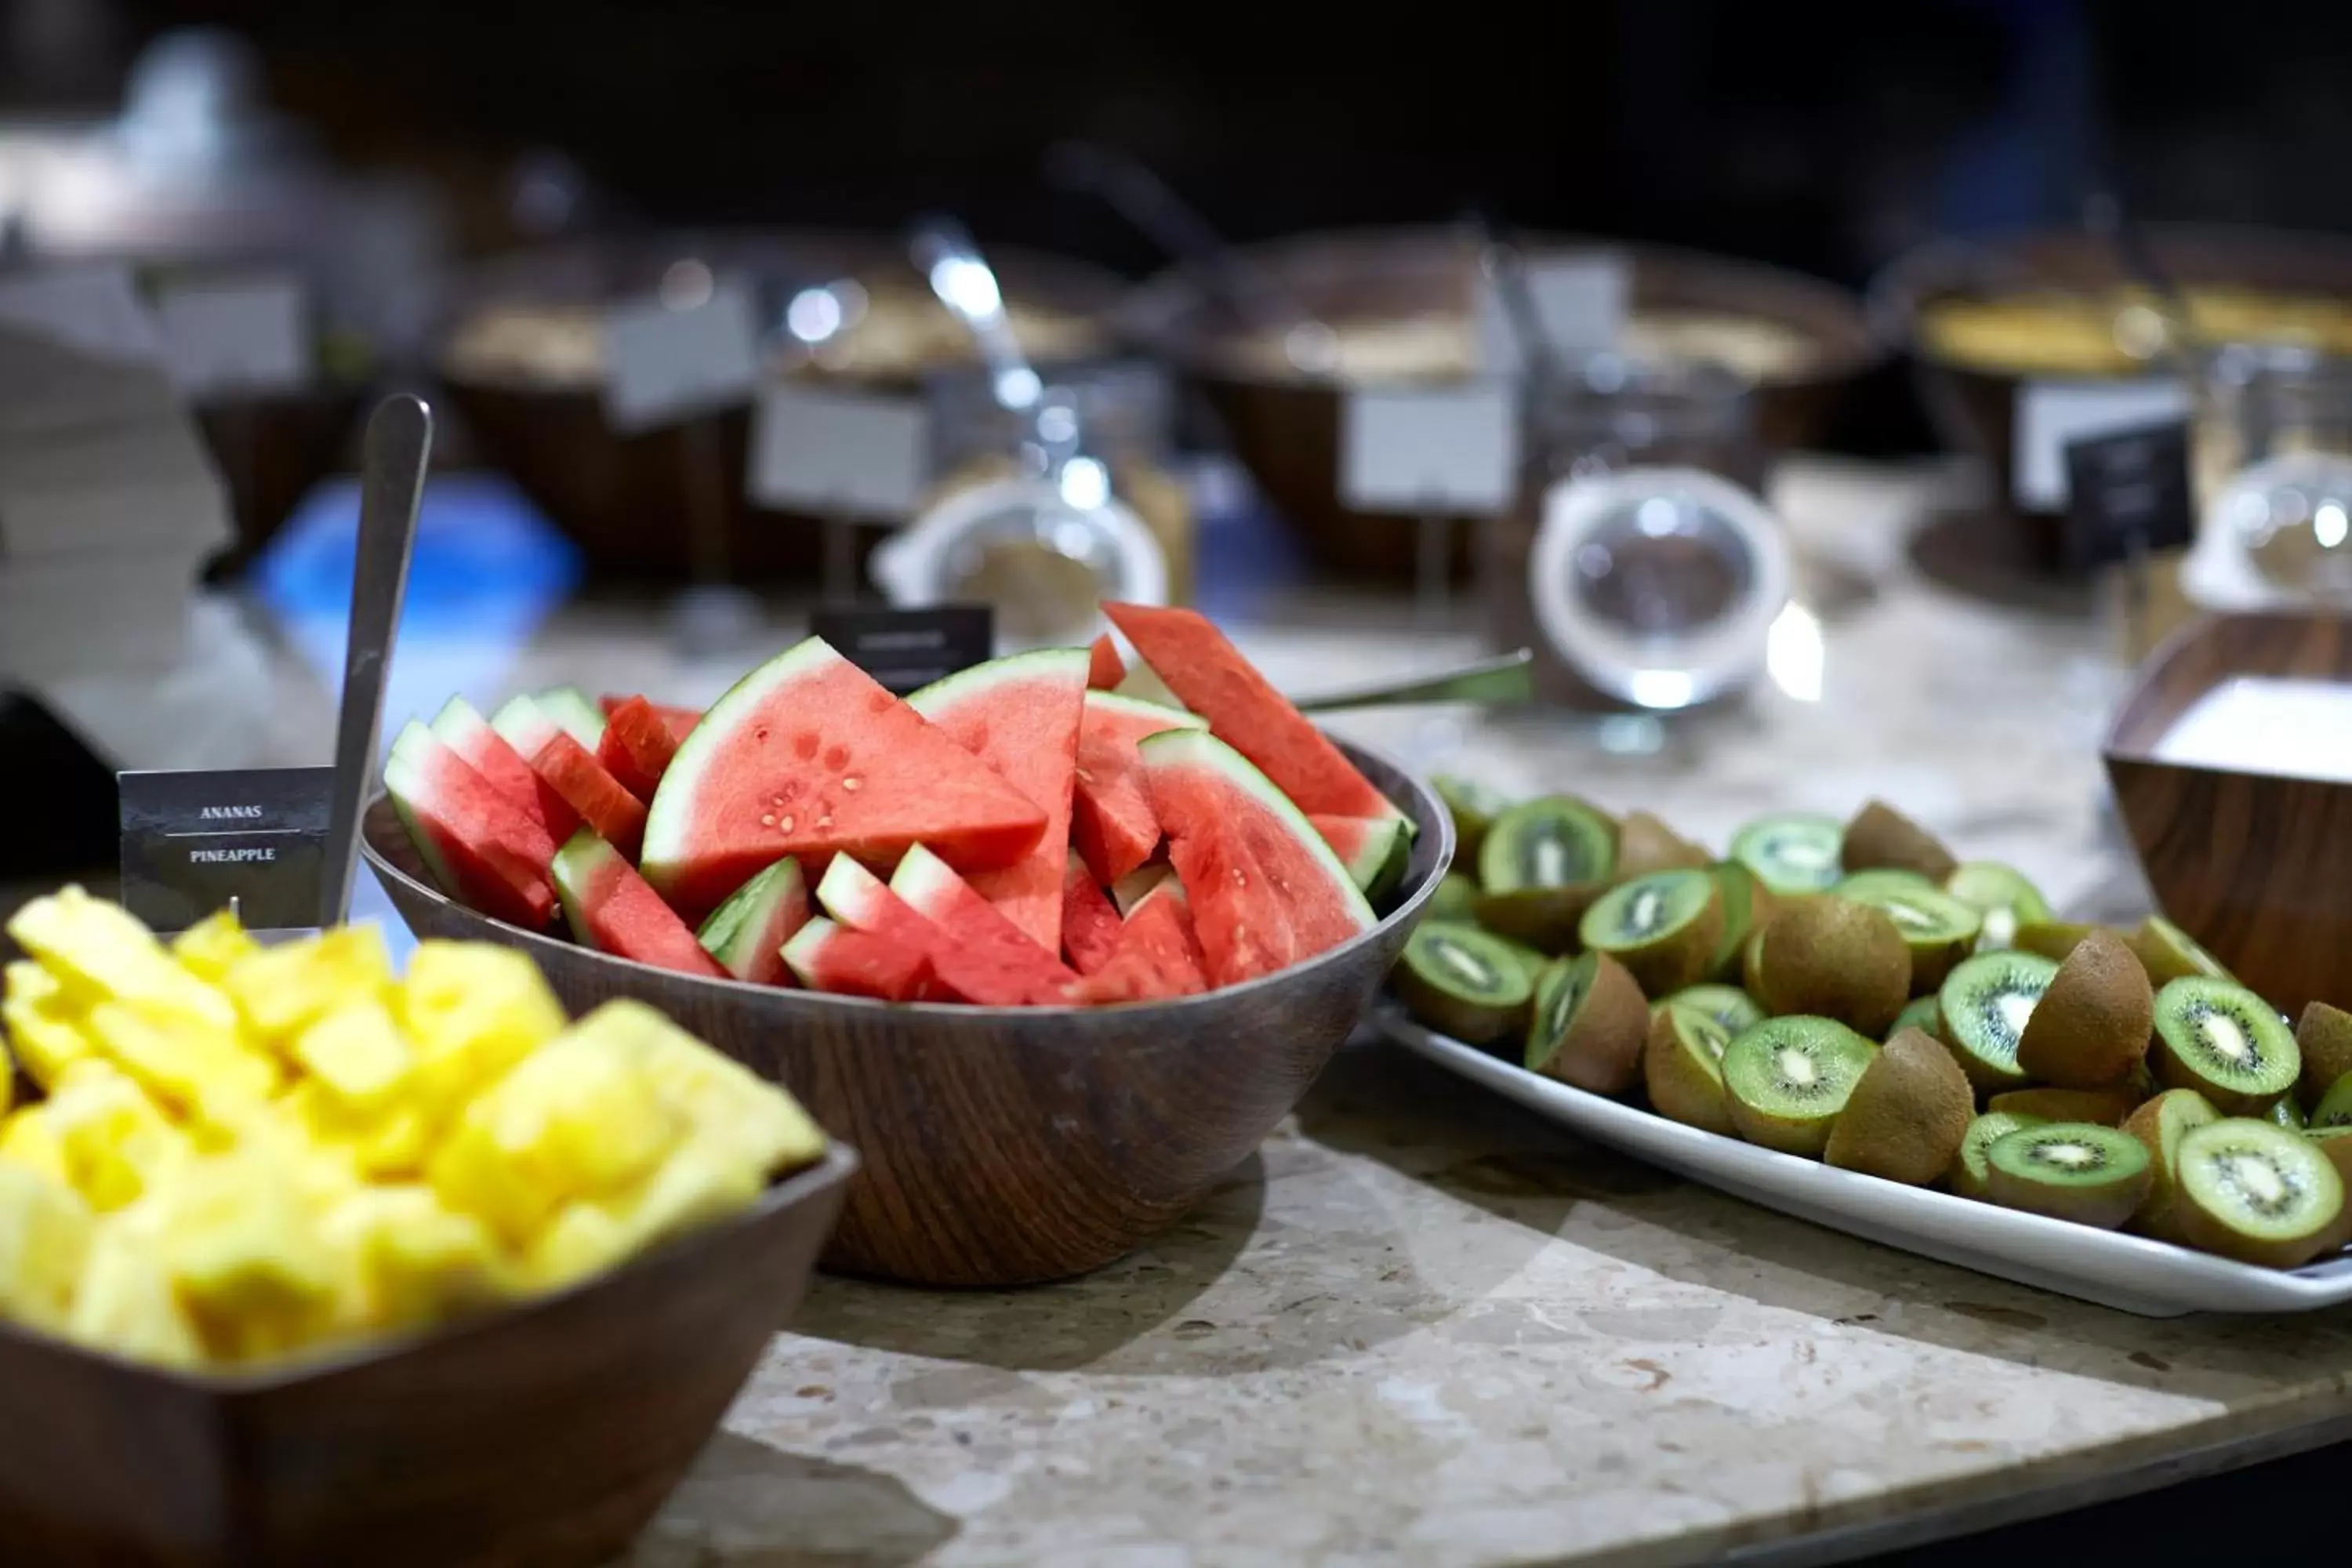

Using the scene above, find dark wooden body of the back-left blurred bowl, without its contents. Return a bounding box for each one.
[433,230,1120,581]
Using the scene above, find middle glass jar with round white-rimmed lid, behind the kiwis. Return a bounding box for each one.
[1479,355,1788,708]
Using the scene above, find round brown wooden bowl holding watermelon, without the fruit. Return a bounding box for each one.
[365,748,1454,1286]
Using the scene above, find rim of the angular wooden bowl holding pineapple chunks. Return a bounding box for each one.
[0,1135,861,1399]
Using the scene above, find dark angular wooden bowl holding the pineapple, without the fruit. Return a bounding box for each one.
[0,1147,858,1568]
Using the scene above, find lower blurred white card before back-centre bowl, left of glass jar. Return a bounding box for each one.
[1338,381,1519,517]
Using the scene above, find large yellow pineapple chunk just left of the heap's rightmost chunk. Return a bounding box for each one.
[428,1032,687,1246]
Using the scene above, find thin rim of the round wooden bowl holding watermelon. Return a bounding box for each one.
[360,736,1454,1027]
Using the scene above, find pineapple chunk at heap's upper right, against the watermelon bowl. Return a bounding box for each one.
[400,942,564,1121]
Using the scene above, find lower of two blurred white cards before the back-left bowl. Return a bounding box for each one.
[743,383,929,522]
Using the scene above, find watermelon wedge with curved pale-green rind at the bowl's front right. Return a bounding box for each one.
[1138,729,1376,985]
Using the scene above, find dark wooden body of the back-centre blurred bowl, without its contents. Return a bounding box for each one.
[1120,228,1884,583]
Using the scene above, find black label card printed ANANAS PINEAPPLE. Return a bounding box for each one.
[115,769,334,931]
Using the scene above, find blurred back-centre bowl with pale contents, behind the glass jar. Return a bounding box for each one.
[1122,228,1882,581]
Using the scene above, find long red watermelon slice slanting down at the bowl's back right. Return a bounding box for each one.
[1103,604,1402,818]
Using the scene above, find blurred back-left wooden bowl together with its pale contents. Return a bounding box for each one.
[433,230,1120,579]
